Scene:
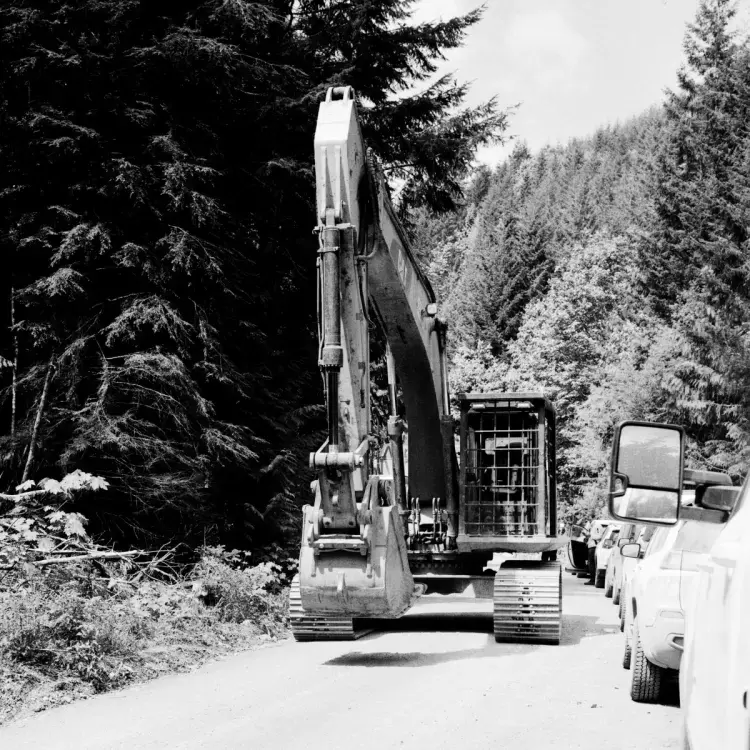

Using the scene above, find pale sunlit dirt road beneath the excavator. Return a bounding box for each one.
[0,573,680,750]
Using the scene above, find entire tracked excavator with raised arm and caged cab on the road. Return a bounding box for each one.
[289,87,567,644]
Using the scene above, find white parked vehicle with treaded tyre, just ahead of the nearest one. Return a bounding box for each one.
[621,520,721,704]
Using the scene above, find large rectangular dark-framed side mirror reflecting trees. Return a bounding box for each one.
[609,422,685,528]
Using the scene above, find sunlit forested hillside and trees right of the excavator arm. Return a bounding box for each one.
[413,0,750,518]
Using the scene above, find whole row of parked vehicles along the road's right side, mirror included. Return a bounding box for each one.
[595,423,750,750]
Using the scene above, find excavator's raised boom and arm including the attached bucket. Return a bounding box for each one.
[299,87,458,617]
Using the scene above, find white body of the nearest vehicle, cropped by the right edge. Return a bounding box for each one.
[680,479,750,750]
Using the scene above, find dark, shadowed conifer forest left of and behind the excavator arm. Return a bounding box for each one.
[0,0,506,549]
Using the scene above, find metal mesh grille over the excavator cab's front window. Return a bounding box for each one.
[464,410,544,536]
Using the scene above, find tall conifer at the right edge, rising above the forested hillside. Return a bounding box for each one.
[646,0,750,472]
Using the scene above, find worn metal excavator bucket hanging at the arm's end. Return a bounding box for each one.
[299,477,422,618]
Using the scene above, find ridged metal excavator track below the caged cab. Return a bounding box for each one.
[493,560,562,645]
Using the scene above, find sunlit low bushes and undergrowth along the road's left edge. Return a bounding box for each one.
[0,471,296,724]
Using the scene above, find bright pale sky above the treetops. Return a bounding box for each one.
[414,0,750,165]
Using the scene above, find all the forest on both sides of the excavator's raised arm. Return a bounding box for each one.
[0,0,750,548]
